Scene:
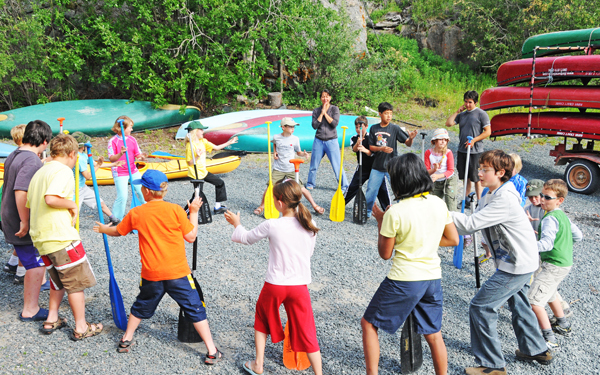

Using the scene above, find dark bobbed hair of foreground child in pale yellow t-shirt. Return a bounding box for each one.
[387,153,433,199]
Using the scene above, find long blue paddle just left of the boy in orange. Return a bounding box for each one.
[85,143,127,331]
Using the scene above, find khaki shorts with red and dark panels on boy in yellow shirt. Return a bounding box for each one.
[42,241,96,294]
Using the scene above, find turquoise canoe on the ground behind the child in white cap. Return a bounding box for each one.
[225,115,381,152]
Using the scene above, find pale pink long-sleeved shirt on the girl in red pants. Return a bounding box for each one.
[231,217,317,285]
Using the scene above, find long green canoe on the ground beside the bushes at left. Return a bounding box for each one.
[0,99,200,137]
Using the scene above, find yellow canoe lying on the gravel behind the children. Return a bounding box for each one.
[85,156,242,185]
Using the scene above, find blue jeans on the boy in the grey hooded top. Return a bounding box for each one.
[469,270,548,368]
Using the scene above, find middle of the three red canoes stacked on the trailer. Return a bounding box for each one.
[479,86,600,111]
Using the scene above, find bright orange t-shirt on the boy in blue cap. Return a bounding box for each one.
[117,200,194,281]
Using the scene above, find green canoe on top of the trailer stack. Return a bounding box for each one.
[521,28,600,58]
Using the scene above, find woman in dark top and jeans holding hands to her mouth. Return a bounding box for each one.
[306,89,348,192]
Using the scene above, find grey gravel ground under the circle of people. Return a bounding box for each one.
[0,136,600,374]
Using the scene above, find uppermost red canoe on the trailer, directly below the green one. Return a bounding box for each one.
[496,55,600,86]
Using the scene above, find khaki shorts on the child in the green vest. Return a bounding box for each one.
[528,262,571,306]
